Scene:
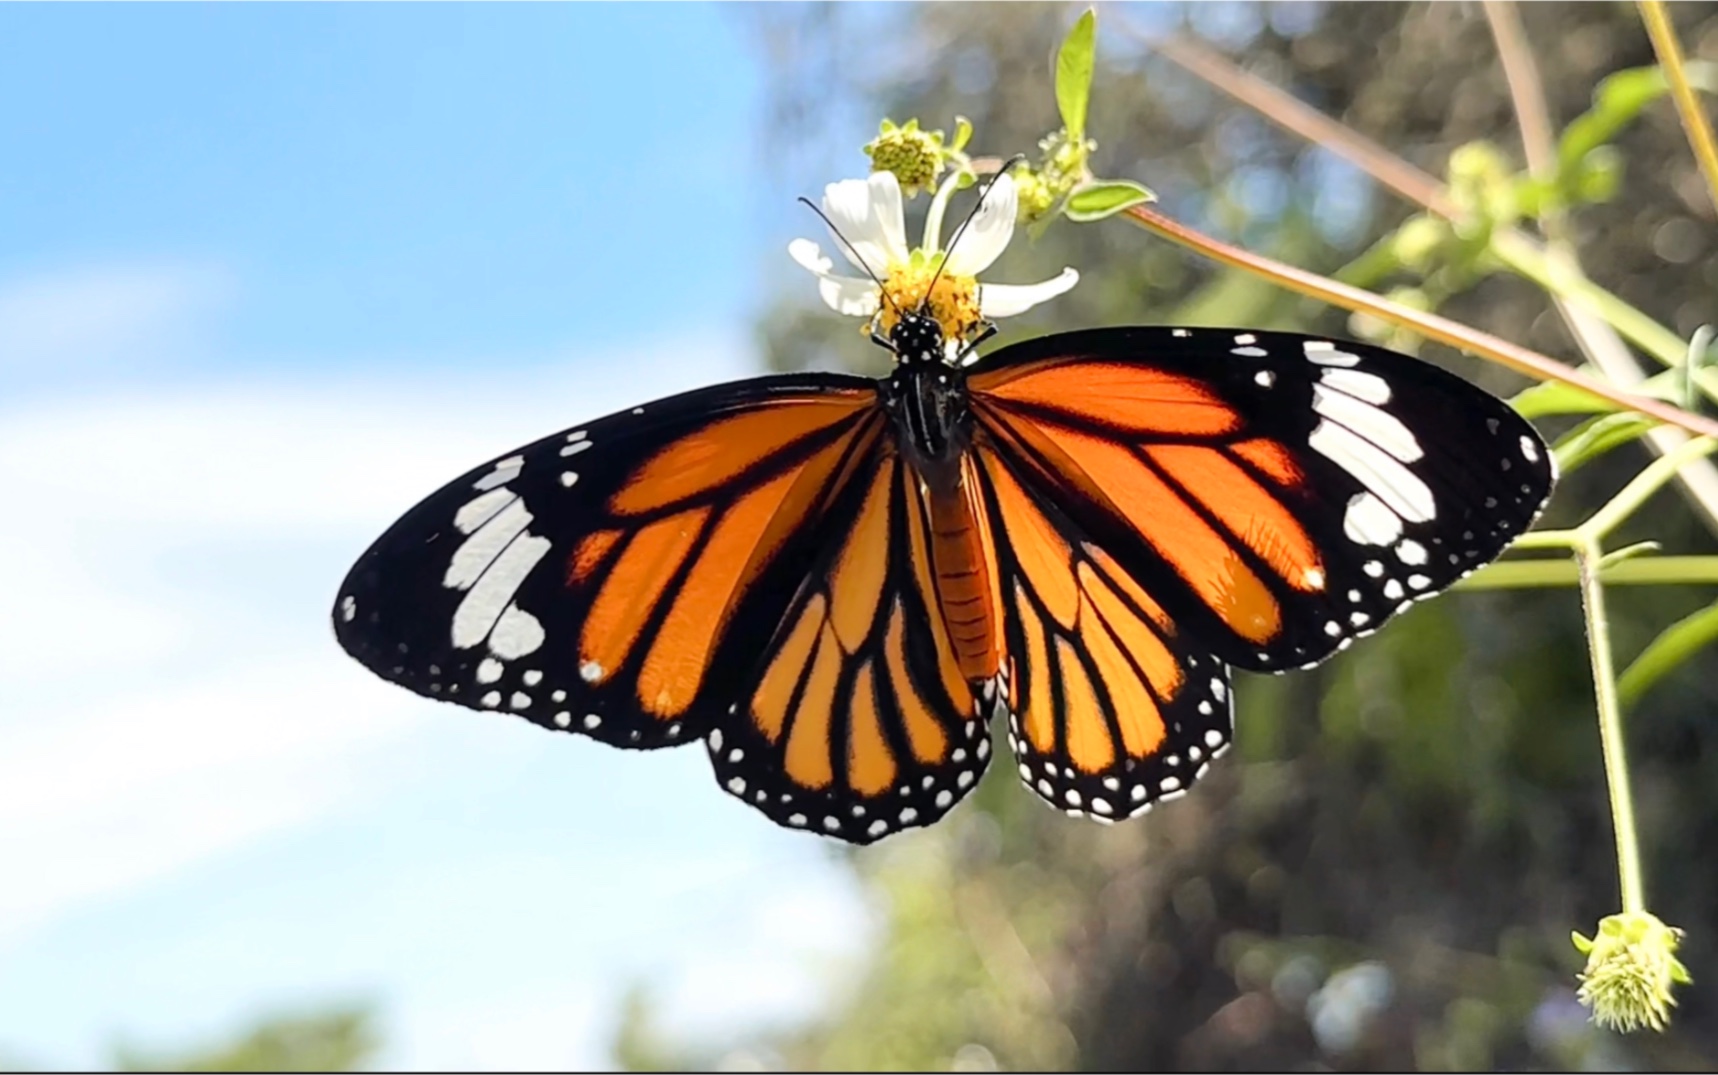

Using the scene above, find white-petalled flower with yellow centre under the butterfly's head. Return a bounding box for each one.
[787,172,1079,342]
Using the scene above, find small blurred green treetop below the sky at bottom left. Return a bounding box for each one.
[113,1005,381,1072]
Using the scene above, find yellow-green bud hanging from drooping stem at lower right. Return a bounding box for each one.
[1572,912,1692,1034]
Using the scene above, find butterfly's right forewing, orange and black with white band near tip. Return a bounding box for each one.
[969,328,1553,671]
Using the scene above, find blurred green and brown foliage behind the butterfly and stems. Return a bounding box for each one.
[629,3,1718,1070]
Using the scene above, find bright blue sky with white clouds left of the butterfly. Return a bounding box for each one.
[0,5,871,1068]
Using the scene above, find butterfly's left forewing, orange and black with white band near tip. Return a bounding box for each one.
[333,374,880,747]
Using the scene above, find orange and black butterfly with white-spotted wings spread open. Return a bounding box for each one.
[333,297,1555,843]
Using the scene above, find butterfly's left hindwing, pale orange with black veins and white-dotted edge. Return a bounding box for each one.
[708,438,990,843]
